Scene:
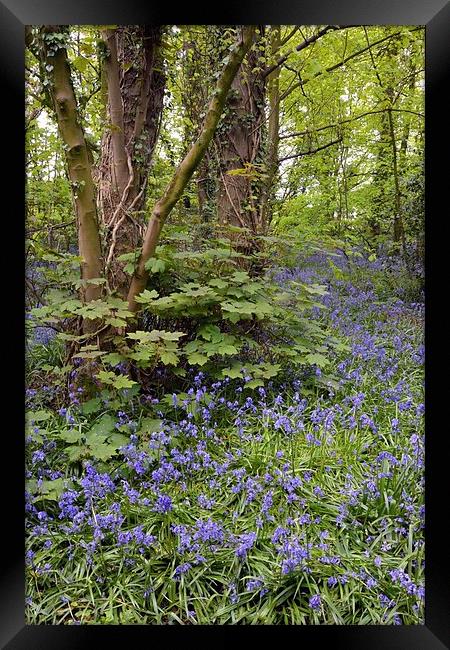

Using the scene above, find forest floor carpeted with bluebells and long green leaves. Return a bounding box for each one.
[26,248,424,625]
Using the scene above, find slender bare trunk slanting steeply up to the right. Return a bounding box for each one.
[128,26,255,312]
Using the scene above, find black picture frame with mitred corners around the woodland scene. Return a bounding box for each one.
[0,0,450,650]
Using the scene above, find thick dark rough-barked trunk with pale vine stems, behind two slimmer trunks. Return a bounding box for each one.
[99,25,165,298]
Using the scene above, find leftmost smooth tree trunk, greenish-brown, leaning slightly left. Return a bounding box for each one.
[41,25,102,320]
